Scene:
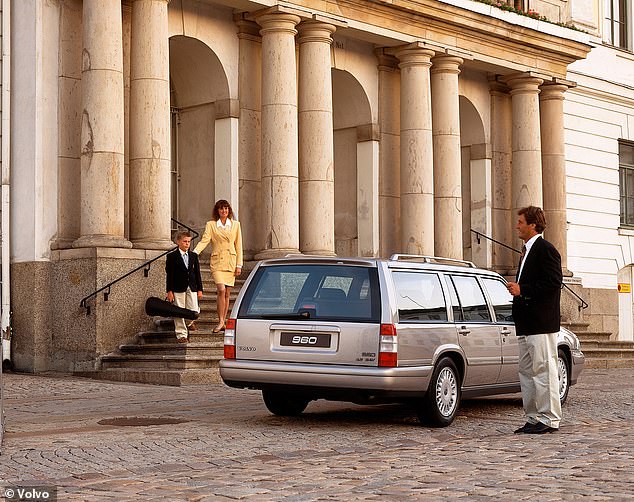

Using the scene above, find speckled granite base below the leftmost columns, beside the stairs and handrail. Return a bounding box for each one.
[11,248,165,372]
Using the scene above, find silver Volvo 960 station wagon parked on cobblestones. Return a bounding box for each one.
[220,255,584,427]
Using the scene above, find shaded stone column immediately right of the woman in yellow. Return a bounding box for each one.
[234,14,262,260]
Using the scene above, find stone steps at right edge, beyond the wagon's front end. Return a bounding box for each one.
[563,322,634,369]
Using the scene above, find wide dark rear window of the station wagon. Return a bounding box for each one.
[238,263,381,323]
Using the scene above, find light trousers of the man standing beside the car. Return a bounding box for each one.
[518,333,561,428]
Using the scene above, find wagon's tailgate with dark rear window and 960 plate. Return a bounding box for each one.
[235,262,380,366]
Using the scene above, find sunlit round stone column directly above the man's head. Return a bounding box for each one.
[507,74,543,218]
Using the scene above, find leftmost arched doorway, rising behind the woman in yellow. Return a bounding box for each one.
[170,35,229,234]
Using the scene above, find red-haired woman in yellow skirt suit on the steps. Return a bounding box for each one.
[194,199,242,333]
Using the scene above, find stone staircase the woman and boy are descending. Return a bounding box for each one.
[78,264,244,386]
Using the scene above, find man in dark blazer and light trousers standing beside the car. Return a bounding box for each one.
[507,206,562,434]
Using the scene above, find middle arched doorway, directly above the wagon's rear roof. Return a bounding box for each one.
[332,69,370,256]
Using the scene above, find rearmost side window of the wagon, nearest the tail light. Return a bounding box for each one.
[393,272,448,322]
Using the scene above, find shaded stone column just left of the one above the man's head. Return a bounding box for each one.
[489,75,517,275]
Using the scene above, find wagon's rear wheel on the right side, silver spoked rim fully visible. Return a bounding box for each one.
[418,357,460,427]
